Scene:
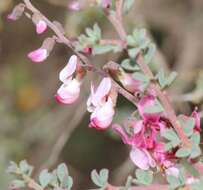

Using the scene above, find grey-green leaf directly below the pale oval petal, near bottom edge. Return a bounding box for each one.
[135,169,153,185]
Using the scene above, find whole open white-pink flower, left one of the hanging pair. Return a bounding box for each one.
[55,55,81,104]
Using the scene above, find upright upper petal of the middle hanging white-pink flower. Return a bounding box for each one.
[92,77,111,106]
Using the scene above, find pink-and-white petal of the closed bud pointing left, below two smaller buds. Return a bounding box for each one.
[28,48,48,62]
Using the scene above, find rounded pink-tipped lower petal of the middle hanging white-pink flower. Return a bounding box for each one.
[90,99,115,129]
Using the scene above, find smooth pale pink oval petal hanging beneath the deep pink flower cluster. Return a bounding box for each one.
[130,147,150,170]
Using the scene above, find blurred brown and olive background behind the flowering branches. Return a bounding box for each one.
[0,0,203,189]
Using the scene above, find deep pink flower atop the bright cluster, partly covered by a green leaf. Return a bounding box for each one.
[138,96,161,122]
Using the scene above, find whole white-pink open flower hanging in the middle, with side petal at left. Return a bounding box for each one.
[87,78,115,130]
